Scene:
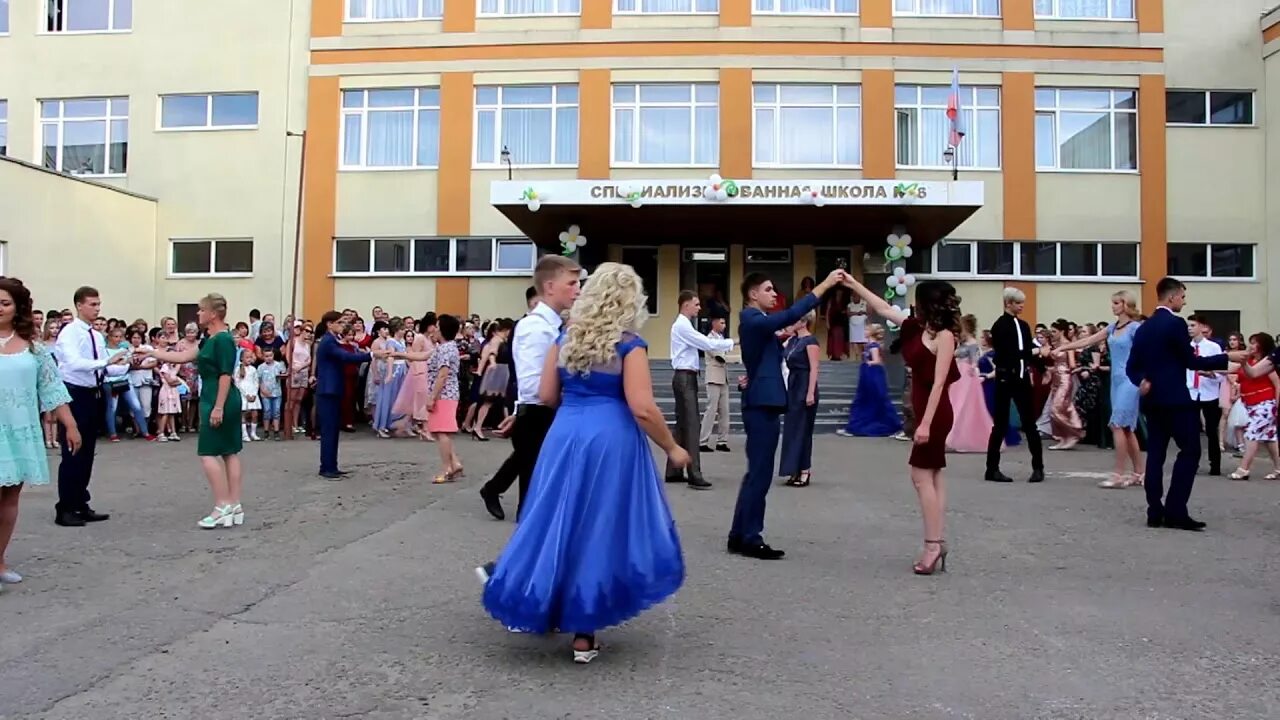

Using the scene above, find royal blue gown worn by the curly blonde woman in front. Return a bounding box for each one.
[484,334,685,634]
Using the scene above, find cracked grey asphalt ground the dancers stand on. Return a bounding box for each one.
[0,436,1280,720]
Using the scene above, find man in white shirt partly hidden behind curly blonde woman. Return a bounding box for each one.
[480,255,581,520]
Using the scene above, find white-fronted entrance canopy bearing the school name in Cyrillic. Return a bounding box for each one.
[489,179,984,249]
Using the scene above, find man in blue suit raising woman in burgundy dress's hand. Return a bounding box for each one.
[728,270,847,560]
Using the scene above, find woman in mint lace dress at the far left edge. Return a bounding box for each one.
[0,278,81,589]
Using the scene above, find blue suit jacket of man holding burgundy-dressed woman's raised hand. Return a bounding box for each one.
[737,292,818,410]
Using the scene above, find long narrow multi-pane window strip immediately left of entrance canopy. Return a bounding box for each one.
[333,237,538,275]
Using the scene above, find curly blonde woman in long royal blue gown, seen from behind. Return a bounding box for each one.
[484,263,689,664]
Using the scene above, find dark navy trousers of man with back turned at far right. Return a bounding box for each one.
[1143,404,1216,519]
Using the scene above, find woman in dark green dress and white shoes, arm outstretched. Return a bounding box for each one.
[146,292,244,529]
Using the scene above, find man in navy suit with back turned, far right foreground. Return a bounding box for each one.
[1125,278,1228,530]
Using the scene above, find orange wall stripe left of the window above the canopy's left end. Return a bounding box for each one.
[435,73,475,236]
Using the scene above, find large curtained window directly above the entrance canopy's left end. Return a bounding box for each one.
[476,85,577,167]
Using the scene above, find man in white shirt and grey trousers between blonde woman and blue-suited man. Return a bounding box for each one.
[667,290,733,489]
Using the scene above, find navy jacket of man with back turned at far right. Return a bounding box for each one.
[1125,307,1228,407]
